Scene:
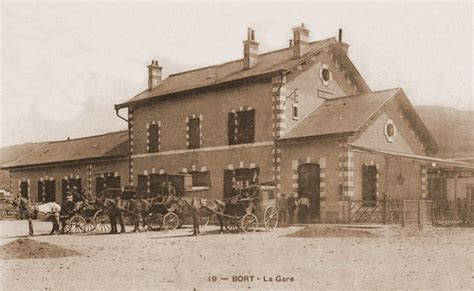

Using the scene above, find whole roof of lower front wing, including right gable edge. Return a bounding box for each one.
[280,88,437,154]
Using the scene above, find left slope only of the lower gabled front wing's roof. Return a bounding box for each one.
[281,88,401,139]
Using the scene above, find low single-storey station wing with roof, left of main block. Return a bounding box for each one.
[2,131,128,203]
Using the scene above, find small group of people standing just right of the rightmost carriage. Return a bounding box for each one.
[277,193,309,223]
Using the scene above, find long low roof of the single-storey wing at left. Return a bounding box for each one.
[3,131,128,168]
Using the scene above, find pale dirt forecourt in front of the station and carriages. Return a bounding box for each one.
[0,221,474,290]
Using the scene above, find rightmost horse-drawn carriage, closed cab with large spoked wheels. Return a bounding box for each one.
[203,183,278,233]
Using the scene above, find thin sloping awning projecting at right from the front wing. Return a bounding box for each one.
[350,145,474,170]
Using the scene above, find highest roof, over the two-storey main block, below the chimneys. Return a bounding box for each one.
[115,38,368,109]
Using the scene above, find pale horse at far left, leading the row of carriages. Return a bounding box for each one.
[11,196,61,236]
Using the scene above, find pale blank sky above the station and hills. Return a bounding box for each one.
[0,1,474,147]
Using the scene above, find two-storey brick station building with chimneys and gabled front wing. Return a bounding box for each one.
[115,25,473,222]
